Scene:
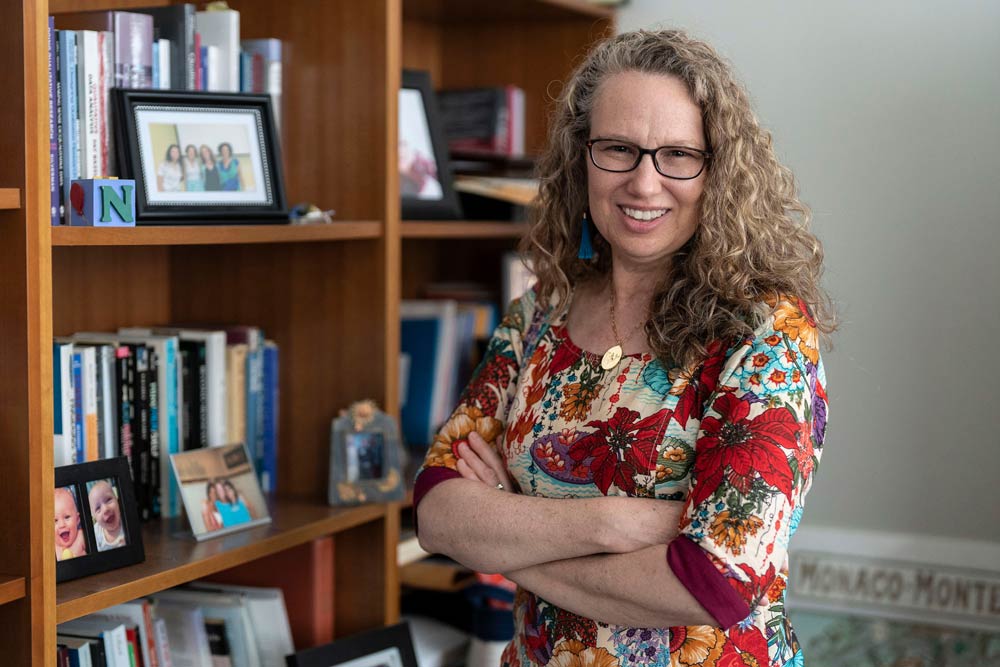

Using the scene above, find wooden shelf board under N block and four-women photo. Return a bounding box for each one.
[52,220,384,246]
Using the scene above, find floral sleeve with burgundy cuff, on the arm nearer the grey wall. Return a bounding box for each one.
[667,299,827,628]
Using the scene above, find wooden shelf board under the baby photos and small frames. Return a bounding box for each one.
[55,500,386,623]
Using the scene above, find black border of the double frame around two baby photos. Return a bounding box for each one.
[53,456,146,583]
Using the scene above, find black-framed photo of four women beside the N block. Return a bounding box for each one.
[112,89,288,225]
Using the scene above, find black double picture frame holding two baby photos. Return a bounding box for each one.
[53,456,146,583]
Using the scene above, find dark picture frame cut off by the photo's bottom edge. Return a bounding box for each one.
[285,622,417,667]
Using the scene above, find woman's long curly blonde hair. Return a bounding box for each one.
[521,30,836,367]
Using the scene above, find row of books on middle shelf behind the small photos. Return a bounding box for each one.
[52,326,279,519]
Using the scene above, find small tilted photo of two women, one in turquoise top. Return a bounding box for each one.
[170,444,271,541]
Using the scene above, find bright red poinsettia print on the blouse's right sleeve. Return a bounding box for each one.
[691,394,798,505]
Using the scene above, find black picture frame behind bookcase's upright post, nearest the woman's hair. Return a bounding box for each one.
[397,70,462,220]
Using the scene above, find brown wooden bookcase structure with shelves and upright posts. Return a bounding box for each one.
[0,0,614,666]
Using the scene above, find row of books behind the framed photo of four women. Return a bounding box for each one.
[49,3,282,225]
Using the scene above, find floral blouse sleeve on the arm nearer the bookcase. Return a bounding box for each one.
[413,290,535,511]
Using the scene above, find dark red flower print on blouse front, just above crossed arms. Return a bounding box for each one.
[569,407,671,495]
